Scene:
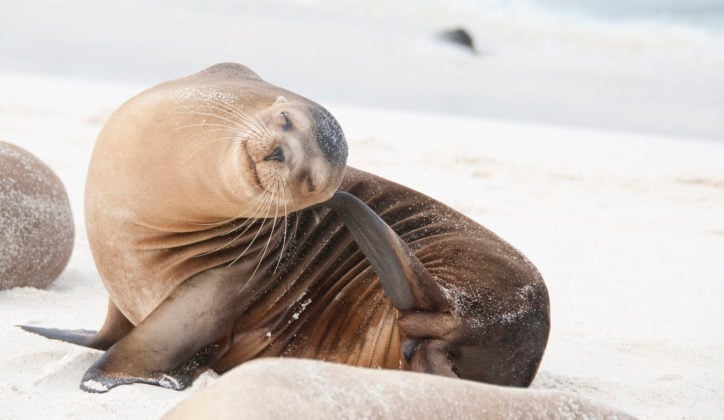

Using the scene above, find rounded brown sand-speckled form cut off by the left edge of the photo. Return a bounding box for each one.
[0,141,74,290]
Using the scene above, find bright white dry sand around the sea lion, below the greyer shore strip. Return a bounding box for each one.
[0,74,724,418]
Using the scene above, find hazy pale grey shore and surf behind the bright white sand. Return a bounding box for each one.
[0,0,724,140]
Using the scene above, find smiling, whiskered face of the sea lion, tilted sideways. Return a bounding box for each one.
[245,96,347,216]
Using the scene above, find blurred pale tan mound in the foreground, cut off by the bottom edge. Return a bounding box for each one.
[164,359,632,419]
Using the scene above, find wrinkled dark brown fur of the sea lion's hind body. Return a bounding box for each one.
[215,168,548,386]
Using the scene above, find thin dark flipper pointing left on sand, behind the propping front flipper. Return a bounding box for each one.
[19,300,133,350]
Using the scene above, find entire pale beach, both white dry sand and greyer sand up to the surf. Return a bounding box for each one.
[0,0,724,418]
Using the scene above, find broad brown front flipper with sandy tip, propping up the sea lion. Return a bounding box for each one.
[80,269,243,392]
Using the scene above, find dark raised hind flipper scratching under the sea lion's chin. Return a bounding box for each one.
[324,191,445,310]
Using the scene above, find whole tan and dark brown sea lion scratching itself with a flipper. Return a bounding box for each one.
[24,64,549,392]
